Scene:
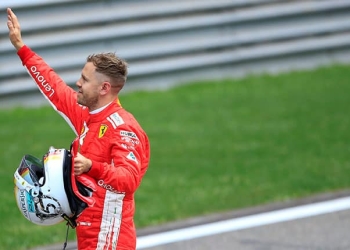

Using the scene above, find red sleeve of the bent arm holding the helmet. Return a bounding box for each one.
[88,126,149,193]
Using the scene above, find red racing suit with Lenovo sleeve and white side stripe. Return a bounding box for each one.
[17,46,150,250]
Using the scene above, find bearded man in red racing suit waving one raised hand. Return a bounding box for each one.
[7,9,150,250]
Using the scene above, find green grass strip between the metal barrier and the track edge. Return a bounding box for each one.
[0,66,350,250]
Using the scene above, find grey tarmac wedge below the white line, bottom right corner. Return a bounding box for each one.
[146,210,350,250]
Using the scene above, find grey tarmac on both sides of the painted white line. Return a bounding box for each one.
[31,190,350,250]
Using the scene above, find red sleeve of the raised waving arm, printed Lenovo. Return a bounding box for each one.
[17,46,83,134]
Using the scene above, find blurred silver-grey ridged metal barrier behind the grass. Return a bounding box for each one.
[0,0,350,107]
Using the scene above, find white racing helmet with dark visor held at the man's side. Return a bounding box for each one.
[14,147,94,228]
